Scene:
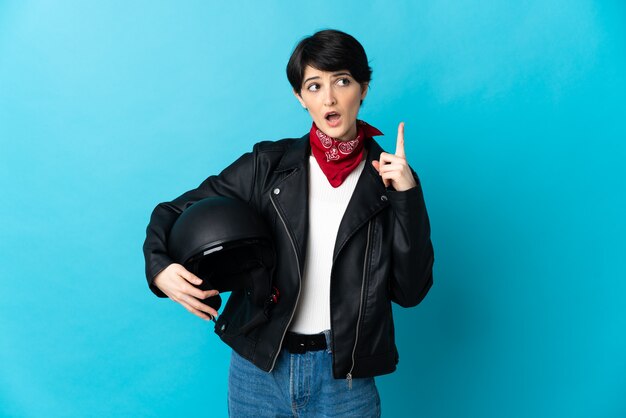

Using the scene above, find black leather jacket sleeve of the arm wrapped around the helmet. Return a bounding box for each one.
[143,146,257,297]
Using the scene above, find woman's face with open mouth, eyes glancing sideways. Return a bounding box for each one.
[294,66,368,141]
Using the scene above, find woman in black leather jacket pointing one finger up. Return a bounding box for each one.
[144,30,433,417]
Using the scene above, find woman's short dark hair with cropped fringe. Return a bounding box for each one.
[287,29,372,94]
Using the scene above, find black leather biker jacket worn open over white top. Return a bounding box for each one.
[144,134,434,379]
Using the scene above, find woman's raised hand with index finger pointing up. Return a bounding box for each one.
[372,122,417,192]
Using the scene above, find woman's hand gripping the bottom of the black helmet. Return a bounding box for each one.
[153,263,219,321]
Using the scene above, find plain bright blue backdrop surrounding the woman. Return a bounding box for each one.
[0,0,626,418]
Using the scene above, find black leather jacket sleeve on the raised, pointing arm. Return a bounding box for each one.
[387,173,434,307]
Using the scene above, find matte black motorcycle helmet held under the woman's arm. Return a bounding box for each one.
[168,197,275,310]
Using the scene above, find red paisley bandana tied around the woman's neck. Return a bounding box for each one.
[309,119,384,187]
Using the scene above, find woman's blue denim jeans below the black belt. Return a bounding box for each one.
[228,331,380,418]
